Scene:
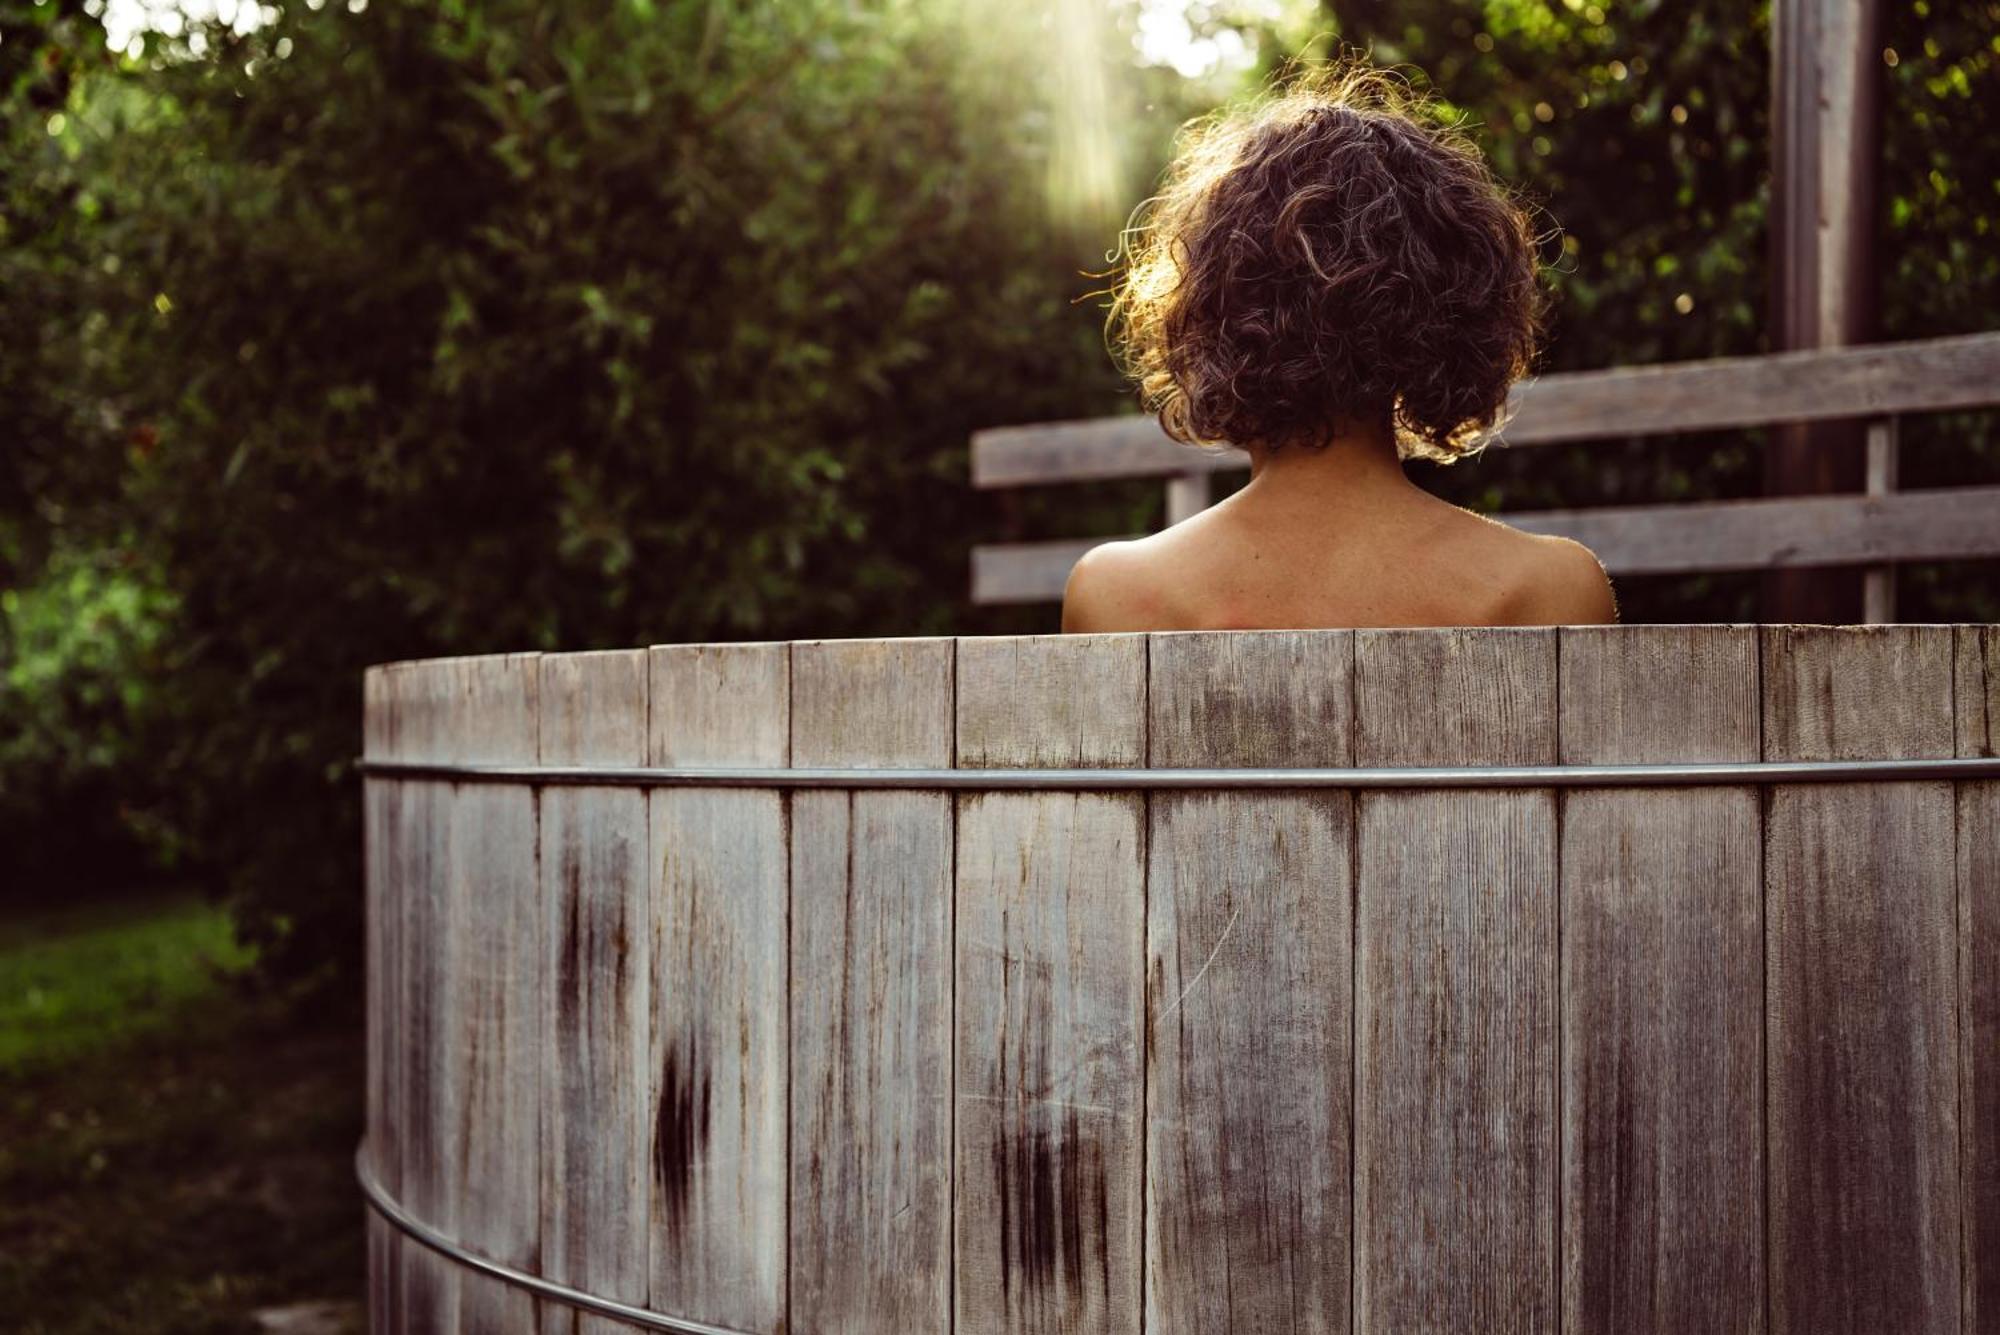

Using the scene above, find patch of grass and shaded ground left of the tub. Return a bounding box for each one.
[0,899,362,1335]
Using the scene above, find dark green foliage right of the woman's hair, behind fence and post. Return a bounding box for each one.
[1328,0,2000,622]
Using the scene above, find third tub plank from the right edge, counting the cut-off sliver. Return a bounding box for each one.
[1560,626,1764,1335]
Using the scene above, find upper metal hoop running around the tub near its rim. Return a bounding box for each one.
[356,757,2000,791]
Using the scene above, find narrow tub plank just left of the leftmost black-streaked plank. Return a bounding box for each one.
[434,654,542,1331]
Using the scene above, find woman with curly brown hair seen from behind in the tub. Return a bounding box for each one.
[1062,72,1618,632]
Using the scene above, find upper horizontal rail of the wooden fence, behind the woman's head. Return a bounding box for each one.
[972,334,2000,488]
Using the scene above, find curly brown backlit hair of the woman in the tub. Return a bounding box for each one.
[1106,64,1542,462]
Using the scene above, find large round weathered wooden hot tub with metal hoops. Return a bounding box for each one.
[360,626,2000,1335]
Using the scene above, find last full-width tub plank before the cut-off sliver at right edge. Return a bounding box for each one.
[1762,626,1962,1335]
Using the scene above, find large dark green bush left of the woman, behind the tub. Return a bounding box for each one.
[8,0,1144,995]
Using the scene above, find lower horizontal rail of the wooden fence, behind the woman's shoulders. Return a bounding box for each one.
[972,488,2000,606]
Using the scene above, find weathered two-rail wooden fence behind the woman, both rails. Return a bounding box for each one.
[972,334,2000,622]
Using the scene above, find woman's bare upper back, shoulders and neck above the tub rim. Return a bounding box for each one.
[1062,442,1618,632]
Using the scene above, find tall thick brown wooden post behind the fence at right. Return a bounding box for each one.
[1764,0,1882,622]
